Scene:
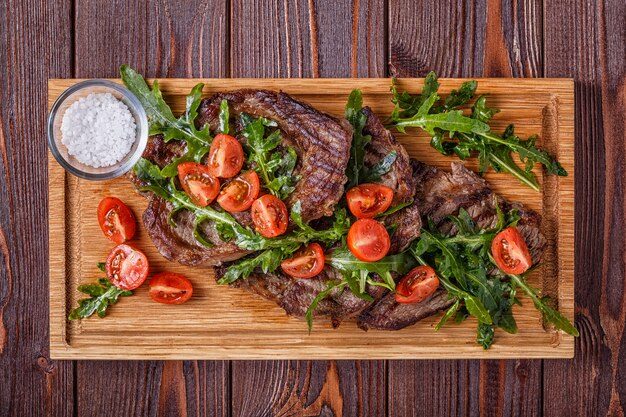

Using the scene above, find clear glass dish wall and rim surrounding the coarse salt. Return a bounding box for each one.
[48,80,148,180]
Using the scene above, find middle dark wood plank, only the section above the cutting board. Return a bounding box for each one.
[231,0,386,77]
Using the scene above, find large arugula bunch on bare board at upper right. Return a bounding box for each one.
[391,72,567,191]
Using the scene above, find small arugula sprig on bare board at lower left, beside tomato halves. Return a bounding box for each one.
[68,276,133,320]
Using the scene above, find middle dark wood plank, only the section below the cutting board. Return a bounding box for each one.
[232,361,386,417]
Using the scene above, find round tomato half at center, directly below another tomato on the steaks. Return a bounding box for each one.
[348,219,391,262]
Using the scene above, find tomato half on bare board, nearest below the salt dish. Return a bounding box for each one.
[98,197,137,244]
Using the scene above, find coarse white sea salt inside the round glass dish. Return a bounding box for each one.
[61,93,136,168]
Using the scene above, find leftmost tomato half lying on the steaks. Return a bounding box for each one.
[177,162,220,207]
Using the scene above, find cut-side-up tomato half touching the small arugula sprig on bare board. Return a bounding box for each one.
[104,243,148,290]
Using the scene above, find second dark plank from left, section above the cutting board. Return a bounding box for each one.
[75,0,229,78]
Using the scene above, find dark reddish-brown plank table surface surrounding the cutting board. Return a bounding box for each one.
[0,0,626,417]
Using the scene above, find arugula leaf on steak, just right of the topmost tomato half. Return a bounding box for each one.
[242,113,300,200]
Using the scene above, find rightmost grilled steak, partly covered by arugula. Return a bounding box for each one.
[357,161,546,330]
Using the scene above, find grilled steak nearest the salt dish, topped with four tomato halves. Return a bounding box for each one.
[131,90,352,266]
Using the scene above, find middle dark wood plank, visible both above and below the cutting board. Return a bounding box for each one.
[231,0,386,416]
